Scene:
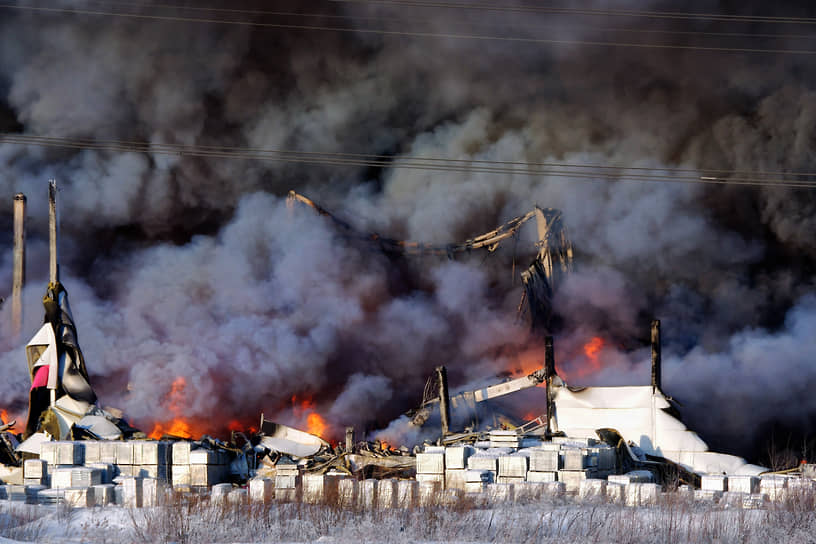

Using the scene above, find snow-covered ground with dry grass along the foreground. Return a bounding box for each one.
[0,493,816,544]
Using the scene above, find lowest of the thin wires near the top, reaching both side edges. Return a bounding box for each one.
[0,4,816,55]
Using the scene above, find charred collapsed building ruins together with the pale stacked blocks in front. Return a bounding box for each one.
[0,183,814,508]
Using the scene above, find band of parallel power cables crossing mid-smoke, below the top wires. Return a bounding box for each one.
[0,134,816,189]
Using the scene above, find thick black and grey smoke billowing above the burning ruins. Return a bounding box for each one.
[0,0,816,459]
